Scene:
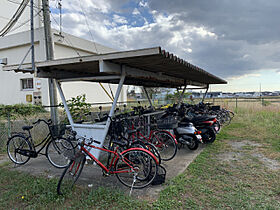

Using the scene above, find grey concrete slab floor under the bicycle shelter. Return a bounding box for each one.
[0,145,204,200]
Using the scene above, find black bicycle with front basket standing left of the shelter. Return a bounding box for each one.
[7,119,75,168]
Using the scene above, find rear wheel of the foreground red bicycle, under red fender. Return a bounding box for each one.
[115,148,158,189]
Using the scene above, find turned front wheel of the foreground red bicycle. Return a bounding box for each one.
[56,154,86,195]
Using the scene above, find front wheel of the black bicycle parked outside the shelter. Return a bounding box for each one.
[46,138,75,168]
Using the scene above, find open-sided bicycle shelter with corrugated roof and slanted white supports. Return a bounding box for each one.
[3,47,227,158]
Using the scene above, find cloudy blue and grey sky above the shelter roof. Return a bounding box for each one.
[50,0,280,92]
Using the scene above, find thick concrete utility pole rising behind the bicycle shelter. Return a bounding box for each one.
[42,0,58,125]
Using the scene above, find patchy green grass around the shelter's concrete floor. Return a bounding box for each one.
[0,106,280,209]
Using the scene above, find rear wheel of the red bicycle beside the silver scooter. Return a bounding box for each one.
[151,131,178,161]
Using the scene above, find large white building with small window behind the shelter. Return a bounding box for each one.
[0,0,126,105]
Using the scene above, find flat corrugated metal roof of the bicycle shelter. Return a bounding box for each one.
[3,47,227,87]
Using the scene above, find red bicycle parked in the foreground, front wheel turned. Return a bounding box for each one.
[57,132,159,195]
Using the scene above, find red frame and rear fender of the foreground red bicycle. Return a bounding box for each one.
[80,144,159,174]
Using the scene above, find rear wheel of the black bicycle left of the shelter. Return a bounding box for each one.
[7,135,32,165]
